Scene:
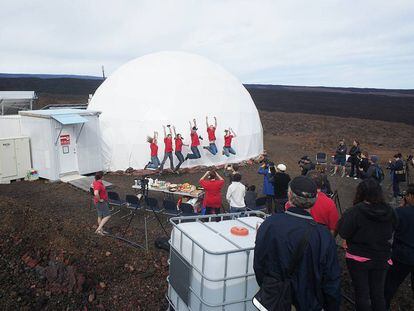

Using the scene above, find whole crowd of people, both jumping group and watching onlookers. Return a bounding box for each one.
[93,135,414,311]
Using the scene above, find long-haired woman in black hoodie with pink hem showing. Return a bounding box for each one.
[338,178,397,311]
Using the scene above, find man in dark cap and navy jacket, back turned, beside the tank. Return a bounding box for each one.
[253,176,341,311]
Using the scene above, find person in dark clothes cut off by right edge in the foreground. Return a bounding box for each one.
[385,184,414,310]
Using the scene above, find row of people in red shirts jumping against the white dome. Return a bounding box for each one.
[144,117,237,174]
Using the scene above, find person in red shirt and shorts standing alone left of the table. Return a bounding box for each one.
[92,172,111,235]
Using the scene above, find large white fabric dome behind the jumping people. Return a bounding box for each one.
[88,52,263,171]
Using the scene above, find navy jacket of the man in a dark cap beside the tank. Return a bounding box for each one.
[253,207,341,311]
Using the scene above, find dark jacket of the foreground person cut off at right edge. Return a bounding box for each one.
[392,206,414,266]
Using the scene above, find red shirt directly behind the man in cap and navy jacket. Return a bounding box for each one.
[285,192,339,230]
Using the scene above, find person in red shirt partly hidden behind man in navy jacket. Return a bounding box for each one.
[286,171,339,236]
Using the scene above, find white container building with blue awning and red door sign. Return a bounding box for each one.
[19,109,103,180]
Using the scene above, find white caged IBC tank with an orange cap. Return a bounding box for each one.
[168,214,264,311]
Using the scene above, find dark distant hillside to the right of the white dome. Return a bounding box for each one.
[245,84,414,126]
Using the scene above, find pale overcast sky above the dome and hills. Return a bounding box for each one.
[0,0,414,89]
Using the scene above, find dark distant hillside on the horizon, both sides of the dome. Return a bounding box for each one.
[0,74,414,125]
